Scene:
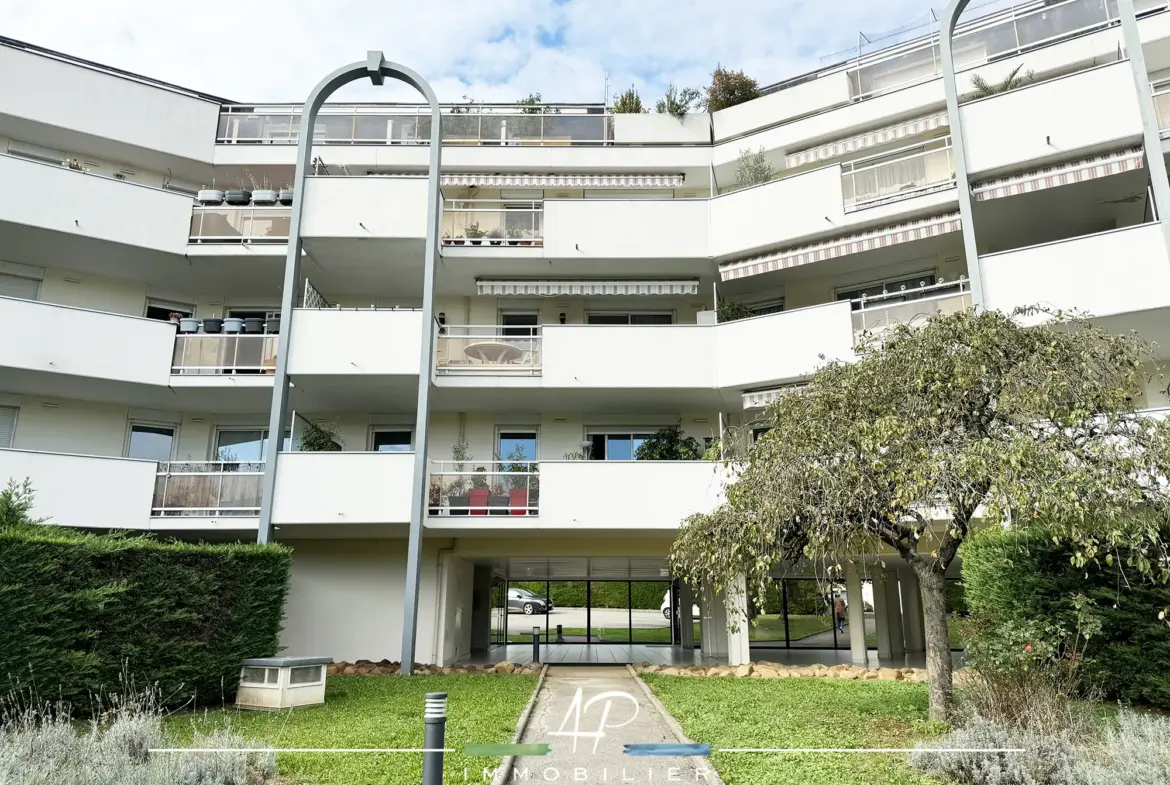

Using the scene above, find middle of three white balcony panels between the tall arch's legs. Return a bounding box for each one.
[289,308,422,376]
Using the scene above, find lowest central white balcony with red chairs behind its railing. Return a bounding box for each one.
[427,461,724,531]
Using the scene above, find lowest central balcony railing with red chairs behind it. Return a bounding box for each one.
[427,461,541,516]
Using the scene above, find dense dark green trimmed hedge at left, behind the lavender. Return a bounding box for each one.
[0,528,291,708]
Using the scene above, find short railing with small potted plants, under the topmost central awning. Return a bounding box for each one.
[442,199,544,248]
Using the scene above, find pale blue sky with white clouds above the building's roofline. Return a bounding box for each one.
[0,0,941,106]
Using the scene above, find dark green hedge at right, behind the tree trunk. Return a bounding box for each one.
[961,528,1170,708]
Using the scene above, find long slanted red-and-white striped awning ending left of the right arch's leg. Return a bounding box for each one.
[720,213,962,281]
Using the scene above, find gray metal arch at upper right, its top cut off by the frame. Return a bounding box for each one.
[938,0,1170,308]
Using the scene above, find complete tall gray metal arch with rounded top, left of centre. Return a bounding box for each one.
[256,50,442,675]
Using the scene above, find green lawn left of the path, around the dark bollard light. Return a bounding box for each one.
[166,674,536,785]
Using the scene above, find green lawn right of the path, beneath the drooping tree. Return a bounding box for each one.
[642,674,942,785]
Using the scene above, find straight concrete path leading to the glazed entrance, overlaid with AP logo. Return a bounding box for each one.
[511,666,720,785]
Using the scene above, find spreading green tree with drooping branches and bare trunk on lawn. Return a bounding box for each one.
[672,309,1170,718]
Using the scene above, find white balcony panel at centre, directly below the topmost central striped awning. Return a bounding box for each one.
[544,199,710,260]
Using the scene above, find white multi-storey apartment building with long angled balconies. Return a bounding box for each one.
[0,0,1170,663]
